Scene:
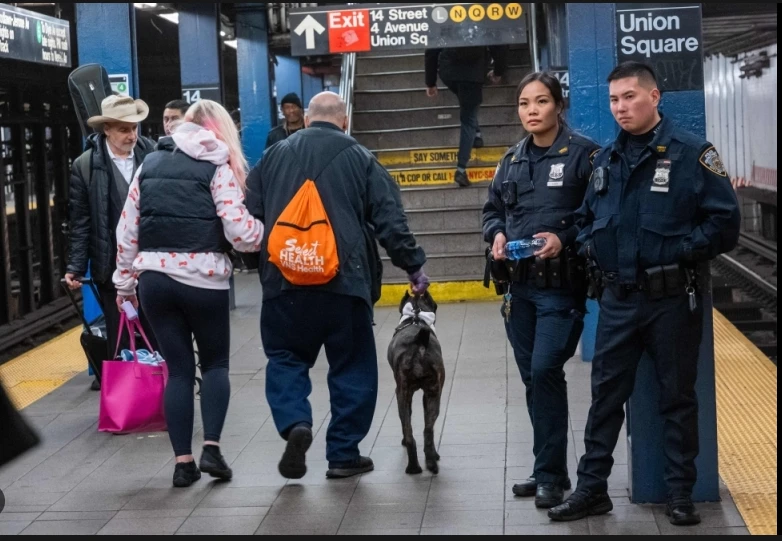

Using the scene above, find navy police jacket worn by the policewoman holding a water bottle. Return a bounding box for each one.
[483,127,600,247]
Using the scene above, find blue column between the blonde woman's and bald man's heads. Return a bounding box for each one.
[236,4,272,166]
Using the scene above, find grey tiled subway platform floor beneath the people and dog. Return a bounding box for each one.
[0,275,749,535]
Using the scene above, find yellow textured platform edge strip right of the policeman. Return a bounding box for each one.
[714,311,777,535]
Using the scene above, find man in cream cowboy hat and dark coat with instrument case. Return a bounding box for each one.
[65,95,155,386]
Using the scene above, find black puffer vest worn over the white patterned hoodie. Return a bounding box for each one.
[139,138,231,253]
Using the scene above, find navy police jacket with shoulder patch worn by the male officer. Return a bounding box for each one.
[577,117,740,284]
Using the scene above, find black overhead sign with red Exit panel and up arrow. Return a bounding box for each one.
[290,3,527,56]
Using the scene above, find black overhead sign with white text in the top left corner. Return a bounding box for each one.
[0,4,71,68]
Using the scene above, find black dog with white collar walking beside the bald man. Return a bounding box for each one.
[388,292,445,474]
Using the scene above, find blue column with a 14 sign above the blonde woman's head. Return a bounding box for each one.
[179,3,223,103]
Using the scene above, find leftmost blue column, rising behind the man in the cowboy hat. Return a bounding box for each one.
[76,3,139,97]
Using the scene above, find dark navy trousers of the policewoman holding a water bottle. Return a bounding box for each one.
[505,282,584,485]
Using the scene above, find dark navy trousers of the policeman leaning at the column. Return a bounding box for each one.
[578,289,703,496]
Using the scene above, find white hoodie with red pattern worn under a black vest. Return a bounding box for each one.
[114,123,263,296]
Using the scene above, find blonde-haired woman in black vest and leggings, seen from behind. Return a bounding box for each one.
[114,100,263,488]
